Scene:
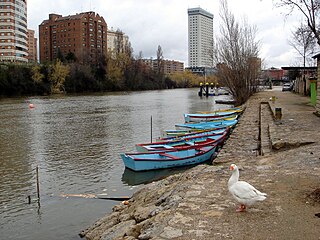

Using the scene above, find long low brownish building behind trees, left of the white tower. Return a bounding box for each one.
[142,58,184,75]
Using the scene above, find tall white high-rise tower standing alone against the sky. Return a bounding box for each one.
[188,7,213,68]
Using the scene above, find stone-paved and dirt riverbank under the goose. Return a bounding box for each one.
[80,88,320,239]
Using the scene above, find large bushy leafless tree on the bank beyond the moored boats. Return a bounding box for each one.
[215,0,261,104]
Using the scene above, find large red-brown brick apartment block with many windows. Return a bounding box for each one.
[39,12,107,64]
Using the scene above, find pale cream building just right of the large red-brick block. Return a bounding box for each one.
[107,28,130,53]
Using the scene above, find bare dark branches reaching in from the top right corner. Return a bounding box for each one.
[276,0,320,45]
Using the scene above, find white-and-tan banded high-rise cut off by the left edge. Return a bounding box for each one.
[0,0,28,62]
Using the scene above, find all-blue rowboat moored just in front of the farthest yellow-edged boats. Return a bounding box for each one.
[175,119,238,130]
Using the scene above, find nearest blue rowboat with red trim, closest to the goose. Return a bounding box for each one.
[120,145,217,171]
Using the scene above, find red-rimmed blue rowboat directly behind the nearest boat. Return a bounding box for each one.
[136,129,229,152]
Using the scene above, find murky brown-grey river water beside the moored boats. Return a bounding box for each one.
[0,89,229,240]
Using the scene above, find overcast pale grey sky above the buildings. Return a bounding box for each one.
[28,0,308,68]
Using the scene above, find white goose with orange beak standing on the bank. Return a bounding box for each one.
[228,164,267,212]
